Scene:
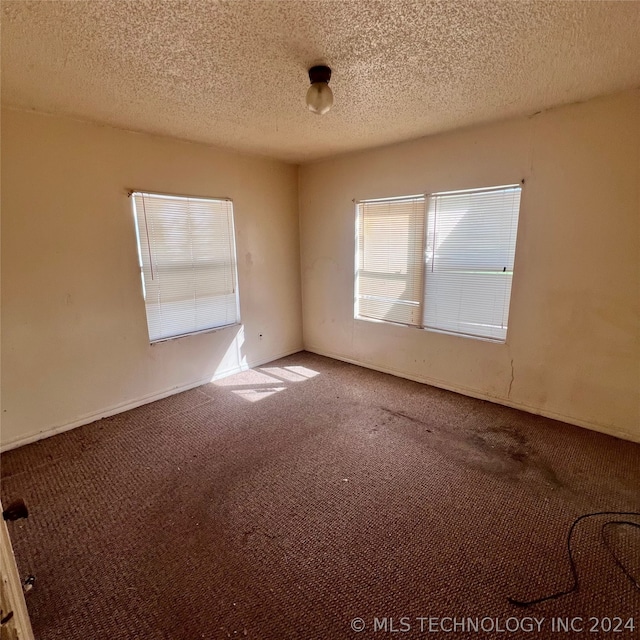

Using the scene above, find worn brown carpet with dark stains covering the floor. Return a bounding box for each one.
[2,352,640,640]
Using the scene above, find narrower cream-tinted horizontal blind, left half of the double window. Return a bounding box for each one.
[356,196,425,325]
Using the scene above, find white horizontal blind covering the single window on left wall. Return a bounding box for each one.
[132,193,239,342]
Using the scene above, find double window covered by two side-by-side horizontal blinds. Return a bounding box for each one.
[355,185,521,342]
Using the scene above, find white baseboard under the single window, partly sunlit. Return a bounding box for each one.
[0,346,303,453]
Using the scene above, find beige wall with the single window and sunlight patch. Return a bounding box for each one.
[2,110,302,448]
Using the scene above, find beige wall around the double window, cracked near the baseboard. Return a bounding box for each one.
[299,91,640,441]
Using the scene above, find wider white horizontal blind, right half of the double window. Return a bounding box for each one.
[424,185,521,342]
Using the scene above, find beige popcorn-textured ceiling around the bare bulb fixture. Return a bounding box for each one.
[2,0,640,162]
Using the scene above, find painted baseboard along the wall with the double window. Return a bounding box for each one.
[305,345,640,443]
